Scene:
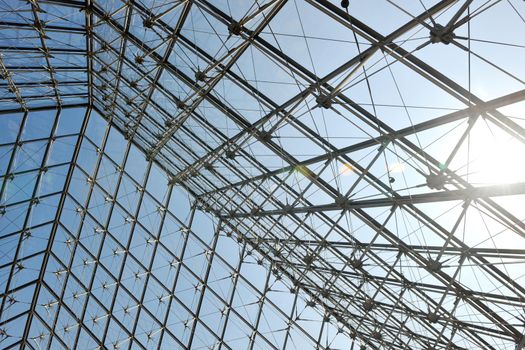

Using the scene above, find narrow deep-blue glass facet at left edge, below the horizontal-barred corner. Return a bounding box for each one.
[0,108,86,348]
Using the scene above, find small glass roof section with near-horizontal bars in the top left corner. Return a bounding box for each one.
[0,0,89,110]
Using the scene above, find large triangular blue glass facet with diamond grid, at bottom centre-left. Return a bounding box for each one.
[17,112,360,349]
